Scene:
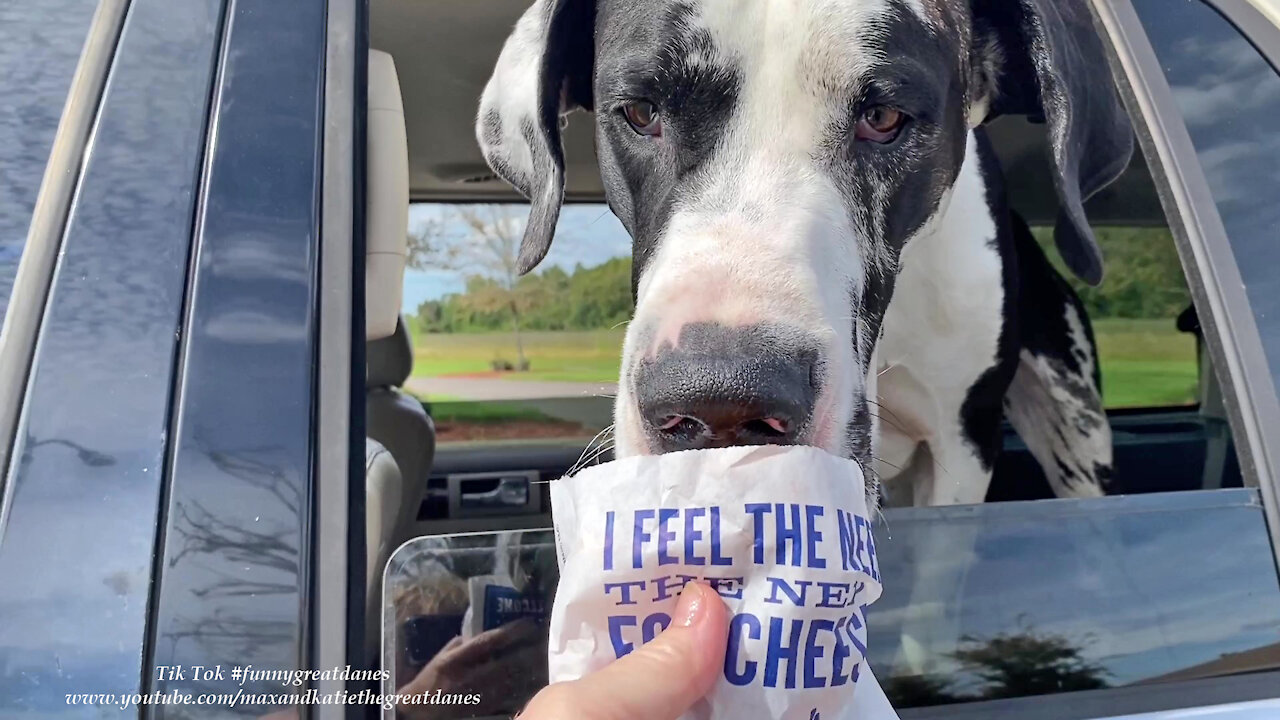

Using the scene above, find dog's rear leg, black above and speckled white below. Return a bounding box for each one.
[1005,210,1111,497]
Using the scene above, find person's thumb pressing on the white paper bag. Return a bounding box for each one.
[520,582,728,720]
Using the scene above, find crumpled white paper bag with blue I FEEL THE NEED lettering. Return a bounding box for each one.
[548,446,897,720]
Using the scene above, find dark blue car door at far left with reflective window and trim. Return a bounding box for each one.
[0,0,221,716]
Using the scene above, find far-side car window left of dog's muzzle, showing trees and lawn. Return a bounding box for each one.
[403,204,632,443]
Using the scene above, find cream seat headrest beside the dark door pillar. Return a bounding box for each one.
[365,50,408,340]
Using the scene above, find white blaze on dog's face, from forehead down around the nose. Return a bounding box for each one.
[614,0,906,456]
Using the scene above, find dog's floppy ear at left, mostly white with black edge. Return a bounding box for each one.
[476,0,595,274]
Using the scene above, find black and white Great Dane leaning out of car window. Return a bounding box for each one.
[476,0,1133,505]
